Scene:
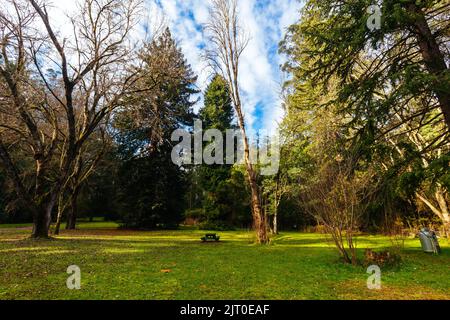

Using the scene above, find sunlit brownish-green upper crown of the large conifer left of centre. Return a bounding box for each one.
[115,28,198,151]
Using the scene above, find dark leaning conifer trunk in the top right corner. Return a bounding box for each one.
[407,3,450,129]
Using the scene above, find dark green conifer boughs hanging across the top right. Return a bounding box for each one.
[281,0,450,132]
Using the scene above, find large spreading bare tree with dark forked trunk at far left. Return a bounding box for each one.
[0,0,140,238]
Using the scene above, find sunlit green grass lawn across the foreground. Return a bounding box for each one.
[0,222,450,299]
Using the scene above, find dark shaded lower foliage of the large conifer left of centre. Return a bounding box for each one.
[117,149,186,229]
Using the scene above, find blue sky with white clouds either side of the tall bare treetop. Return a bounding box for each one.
[147,0,300,131]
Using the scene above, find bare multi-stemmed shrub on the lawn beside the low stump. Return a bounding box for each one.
[302,159,375,264]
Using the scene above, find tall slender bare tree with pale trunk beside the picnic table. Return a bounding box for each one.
[205,0,269,243]
